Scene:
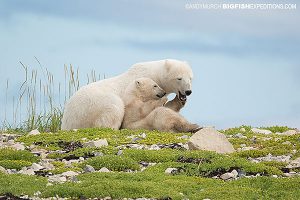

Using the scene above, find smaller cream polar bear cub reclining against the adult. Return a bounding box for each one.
[121,78,201,132]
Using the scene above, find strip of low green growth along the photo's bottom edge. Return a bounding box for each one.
[0,172,300,200]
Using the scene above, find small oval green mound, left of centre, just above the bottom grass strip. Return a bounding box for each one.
[80,155,139,171]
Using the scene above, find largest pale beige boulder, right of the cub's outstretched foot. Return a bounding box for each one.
[188,128,235,153]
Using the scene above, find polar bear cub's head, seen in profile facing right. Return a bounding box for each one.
[135,78,166,101]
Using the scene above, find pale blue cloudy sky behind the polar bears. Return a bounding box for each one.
[0,0,300,128]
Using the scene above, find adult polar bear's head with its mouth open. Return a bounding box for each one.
[163,60,193,101]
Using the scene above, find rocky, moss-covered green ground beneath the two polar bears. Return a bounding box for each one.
[0,126,300,200]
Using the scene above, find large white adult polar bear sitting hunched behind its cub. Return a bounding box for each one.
[61,59,193,130]
